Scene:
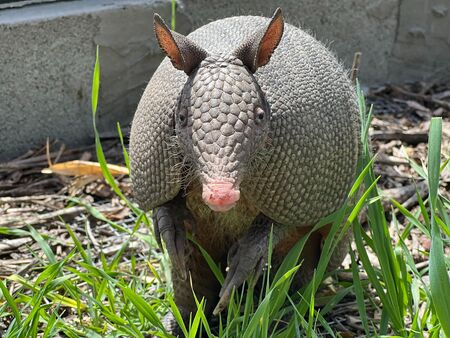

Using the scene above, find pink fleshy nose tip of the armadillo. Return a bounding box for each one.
[202,181,240,212]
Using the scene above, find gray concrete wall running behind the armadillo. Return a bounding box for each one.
[0,0,450,160]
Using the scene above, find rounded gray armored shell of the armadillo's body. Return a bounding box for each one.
[130,16,360,226]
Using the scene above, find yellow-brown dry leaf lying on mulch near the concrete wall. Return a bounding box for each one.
[42,160,129,176]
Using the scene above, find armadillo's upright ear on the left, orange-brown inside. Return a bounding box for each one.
[153,13,208,75]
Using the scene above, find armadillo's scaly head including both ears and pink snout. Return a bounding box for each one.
[155,10,284,212]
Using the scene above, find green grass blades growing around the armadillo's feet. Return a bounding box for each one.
[0,37,450,338]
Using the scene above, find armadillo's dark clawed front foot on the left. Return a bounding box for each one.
[153,198,193,280]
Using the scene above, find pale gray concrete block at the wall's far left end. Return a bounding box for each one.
[0,11,98,159]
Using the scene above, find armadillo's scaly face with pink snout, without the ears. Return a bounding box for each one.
[176,56,270,211]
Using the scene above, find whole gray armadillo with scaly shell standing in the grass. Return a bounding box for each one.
[130,9,360,332]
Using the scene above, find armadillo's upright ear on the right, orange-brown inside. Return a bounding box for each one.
[233,8,284,73]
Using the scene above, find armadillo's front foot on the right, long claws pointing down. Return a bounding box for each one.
[213,217,271,315]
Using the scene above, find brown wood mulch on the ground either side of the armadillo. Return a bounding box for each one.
[0,81,450,337]
